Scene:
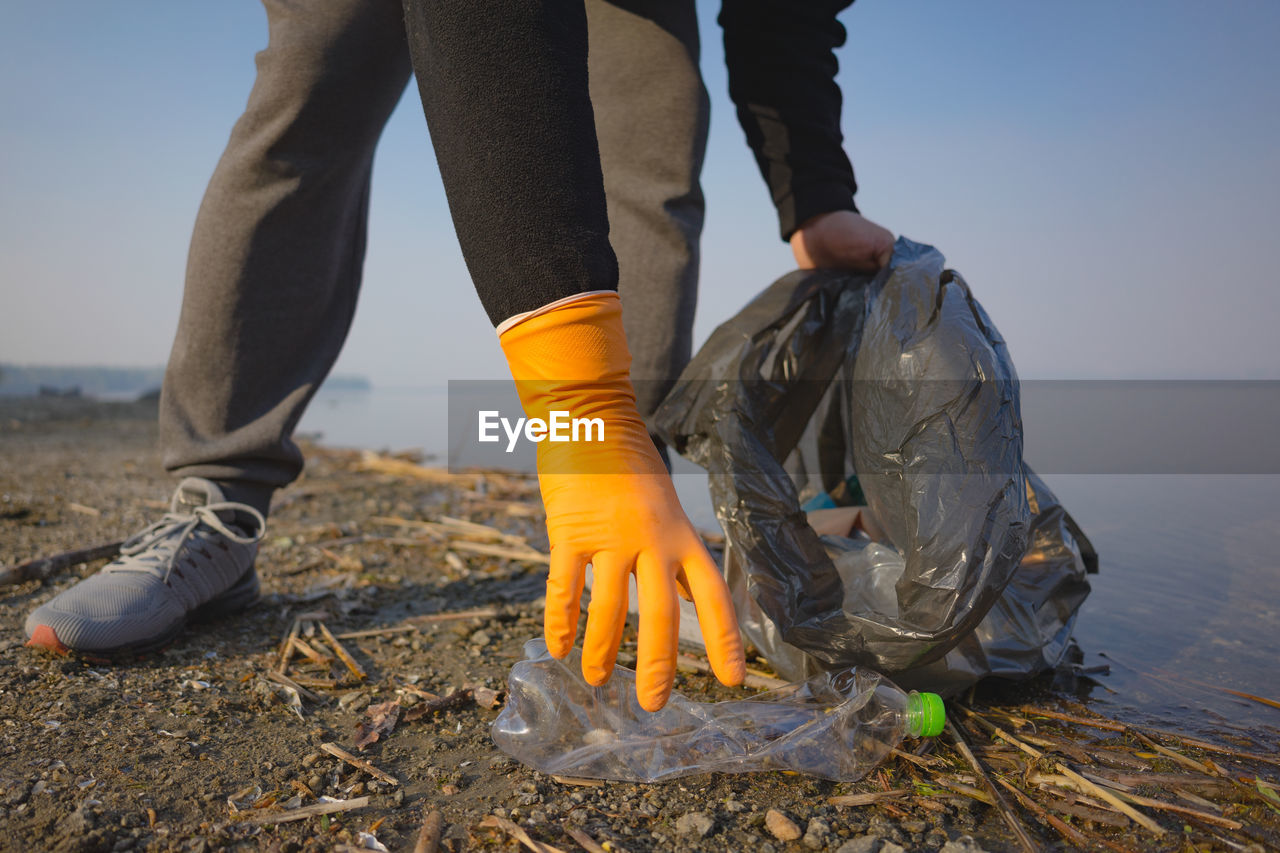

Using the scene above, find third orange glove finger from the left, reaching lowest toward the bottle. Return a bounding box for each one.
[636,555,680,711]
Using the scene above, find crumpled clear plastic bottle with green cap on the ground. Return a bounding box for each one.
[492,639,945,783]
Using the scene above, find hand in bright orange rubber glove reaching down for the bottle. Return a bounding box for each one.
[499,292,745,711]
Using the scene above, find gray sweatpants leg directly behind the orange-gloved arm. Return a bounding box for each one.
[586,0,710,418]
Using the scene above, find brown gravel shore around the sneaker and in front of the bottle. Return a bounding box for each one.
[0,400,1274,853]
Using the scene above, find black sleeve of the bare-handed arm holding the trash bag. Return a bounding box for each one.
[719,0,858,240]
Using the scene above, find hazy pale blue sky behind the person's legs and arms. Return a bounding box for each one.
[0,0,1280,384]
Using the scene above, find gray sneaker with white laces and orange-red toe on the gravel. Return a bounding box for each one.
[27,476,266,660]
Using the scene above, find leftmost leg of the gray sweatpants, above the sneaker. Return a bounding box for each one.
[160,0,411,514]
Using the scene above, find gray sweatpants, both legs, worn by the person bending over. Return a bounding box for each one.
[160,0,709,512]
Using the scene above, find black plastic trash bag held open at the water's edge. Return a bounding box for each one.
[654,238,1096,693]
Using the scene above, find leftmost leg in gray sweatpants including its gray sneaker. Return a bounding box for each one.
[27,0,410,658]
